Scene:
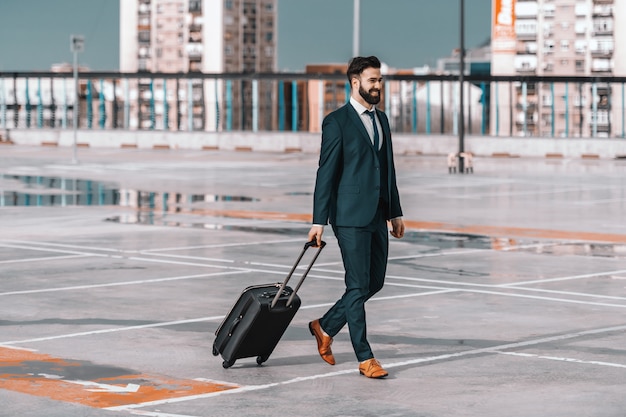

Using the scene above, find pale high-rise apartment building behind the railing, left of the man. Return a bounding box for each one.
[120,0,278,131]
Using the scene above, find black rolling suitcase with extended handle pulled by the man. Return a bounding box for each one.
[213,241,326,368]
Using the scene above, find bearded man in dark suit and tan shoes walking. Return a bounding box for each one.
[309,56,404,378]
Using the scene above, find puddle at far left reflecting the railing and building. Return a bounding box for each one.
[0,174,257,211]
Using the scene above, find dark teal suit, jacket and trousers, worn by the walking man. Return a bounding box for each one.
[313,103,402,361]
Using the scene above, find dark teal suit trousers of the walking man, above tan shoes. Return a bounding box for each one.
[320,204,389,362]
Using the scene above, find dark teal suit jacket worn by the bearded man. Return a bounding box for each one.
[313,102,402,227]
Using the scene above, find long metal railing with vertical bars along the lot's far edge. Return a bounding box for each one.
[0,72,626,138]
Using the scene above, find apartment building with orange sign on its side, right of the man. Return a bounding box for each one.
[490,0,626,137]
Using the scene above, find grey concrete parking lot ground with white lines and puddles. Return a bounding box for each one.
[0,145,626,417]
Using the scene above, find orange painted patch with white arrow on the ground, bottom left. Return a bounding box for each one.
[0,348,238,408]
